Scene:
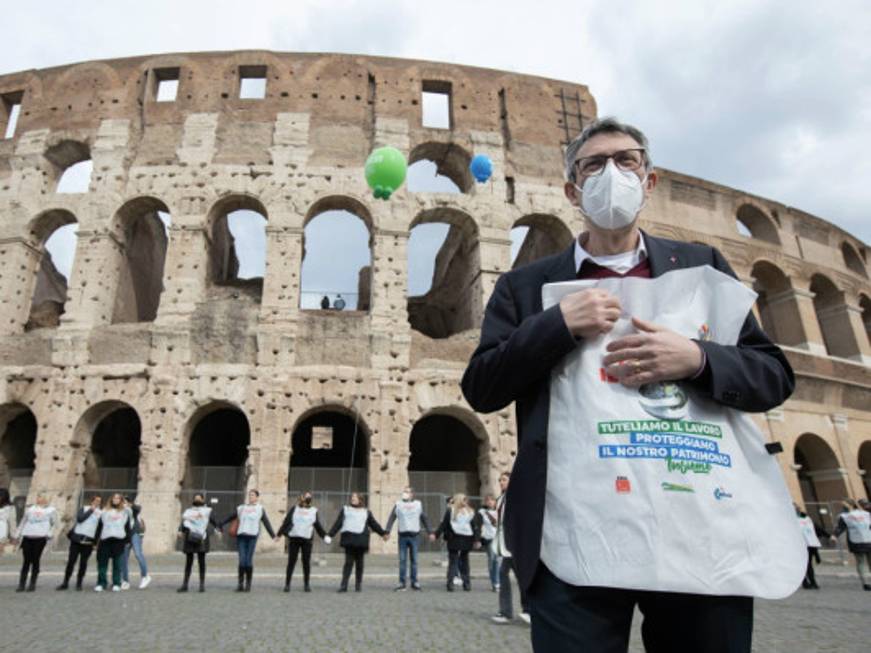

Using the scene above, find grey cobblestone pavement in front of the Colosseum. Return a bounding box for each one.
[0,553,871,653]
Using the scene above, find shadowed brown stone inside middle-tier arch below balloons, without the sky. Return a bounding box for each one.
[408,207,482,338]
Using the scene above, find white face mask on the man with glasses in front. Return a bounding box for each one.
[575,159,646,229]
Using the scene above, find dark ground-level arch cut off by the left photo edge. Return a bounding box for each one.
[0,402,39,517]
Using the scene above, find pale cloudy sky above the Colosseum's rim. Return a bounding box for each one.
[0,0,871,285]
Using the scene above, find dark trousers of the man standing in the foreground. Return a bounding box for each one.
[528,564,753,653]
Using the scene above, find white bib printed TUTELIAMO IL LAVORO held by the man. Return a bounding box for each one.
[541,266,807,598]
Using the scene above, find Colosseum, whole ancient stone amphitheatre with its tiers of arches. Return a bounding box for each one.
[0,51,871,552]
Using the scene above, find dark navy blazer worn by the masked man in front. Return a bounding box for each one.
[462,234,795,588]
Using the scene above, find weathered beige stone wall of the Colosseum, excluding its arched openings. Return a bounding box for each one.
[0,51,871,550]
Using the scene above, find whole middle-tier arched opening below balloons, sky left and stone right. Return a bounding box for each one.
[408,208,481,338]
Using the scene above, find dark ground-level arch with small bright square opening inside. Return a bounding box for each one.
[288,402,372,494]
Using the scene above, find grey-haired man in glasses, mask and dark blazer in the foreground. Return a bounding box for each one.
[462,118,794,653]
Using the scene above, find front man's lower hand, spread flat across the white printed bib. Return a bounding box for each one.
[602,317,703,388]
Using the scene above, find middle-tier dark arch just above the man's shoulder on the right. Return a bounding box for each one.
[750,260,807,345]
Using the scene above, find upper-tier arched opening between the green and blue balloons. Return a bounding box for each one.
[406,142,474,193]
